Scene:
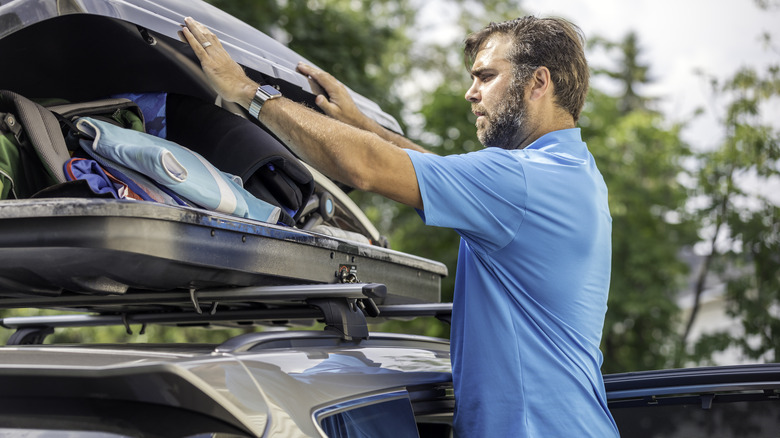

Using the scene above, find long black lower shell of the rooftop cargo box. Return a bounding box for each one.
[0,198,446,304]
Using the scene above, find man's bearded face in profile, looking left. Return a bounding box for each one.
[466,35,530,149]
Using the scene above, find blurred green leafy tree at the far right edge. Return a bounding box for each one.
[676,61,780,364]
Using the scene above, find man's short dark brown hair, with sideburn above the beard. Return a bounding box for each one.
[464,16,590,122]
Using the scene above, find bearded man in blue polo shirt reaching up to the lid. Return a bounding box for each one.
[182,17,618,437]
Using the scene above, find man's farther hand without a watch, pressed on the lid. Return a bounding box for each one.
[298,63,371,130]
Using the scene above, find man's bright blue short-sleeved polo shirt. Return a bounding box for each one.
[408,129,618,438]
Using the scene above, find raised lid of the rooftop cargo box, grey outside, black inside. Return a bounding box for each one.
[0,0,401,133]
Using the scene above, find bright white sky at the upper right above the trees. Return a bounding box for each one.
[522,0,780,147]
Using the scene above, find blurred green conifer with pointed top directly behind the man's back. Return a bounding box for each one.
[580,34,695,372]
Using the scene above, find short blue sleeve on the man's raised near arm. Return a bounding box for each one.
[407,148,527,253]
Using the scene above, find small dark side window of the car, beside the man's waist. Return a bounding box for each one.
[320,393,419,438]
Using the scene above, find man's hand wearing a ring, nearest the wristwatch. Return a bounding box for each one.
[179,17,258,108]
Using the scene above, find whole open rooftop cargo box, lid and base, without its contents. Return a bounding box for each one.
[0,0,447,338]
